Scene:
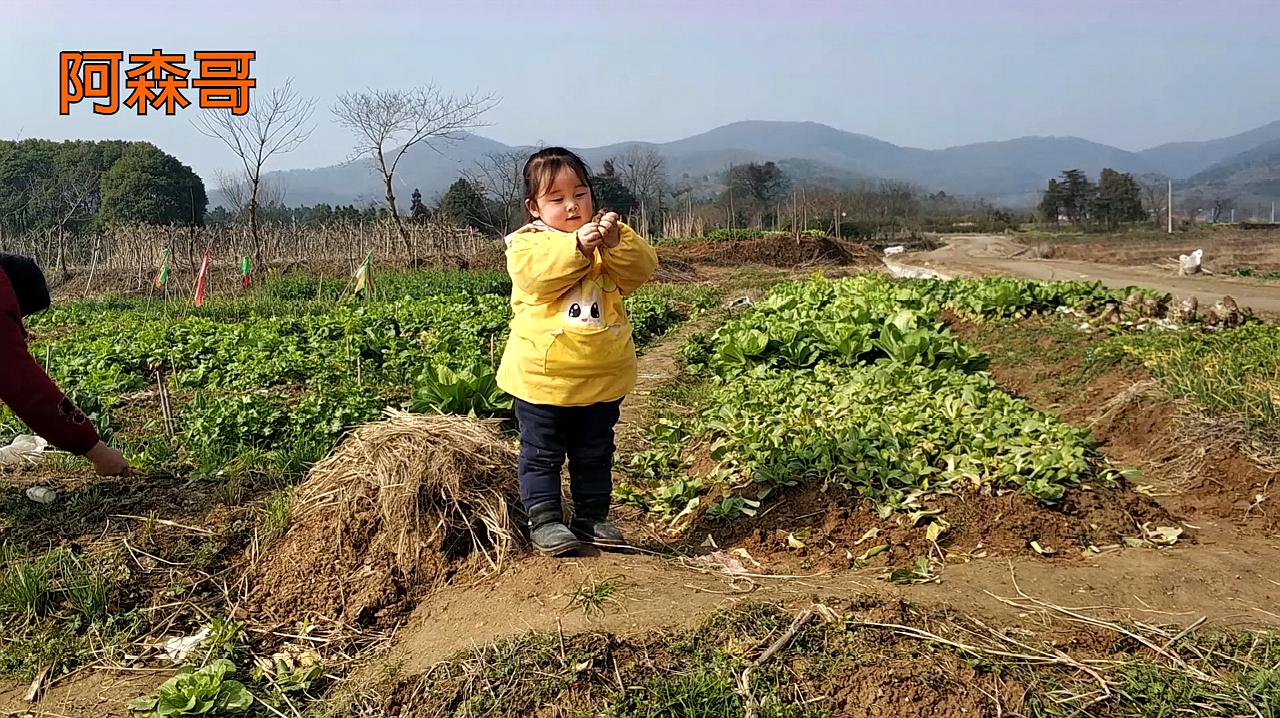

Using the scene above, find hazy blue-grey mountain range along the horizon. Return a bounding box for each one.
[232,122,1280,205]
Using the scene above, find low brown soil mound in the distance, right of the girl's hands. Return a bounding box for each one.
[662,237,879,269]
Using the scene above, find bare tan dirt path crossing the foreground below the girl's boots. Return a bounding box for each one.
[397,519,1280,674]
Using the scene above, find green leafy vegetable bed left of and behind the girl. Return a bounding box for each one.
[3,271,714,476]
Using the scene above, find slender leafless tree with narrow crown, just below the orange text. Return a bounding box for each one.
[193,79,316,267]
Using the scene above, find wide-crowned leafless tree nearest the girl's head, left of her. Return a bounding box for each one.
[333,84,498,251]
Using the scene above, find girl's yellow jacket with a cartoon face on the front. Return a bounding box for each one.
[498,223,658,406]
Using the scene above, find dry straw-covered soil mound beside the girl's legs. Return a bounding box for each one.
[250,412,518,626]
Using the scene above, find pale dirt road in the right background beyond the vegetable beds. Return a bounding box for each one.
[886,235,1280,315]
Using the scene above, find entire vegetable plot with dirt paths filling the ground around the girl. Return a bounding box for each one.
[0,258,1280,718]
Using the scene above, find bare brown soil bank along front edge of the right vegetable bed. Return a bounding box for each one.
[690,486,1178,570]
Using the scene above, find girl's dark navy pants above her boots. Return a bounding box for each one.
[516,399,622,509]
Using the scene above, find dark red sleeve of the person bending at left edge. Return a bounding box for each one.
[0,271,99,454]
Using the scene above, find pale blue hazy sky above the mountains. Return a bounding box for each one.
[0,0,1280,180]
